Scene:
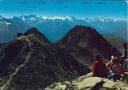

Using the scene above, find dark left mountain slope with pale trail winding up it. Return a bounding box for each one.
[0,28,88,90]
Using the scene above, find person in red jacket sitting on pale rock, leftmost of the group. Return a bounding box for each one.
[92,55,108,78]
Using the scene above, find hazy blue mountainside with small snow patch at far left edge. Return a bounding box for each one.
[0,16,28,43]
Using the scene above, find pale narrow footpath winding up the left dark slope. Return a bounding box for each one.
[0,37,32,90]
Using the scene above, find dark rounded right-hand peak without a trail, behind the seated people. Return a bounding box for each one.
[57,25,119,63]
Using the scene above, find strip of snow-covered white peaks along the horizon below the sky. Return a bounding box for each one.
[0,15,127,25]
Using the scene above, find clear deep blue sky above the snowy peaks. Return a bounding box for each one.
[0,0,127,19]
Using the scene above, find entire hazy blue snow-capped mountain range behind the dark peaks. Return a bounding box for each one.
[0,15,127,42]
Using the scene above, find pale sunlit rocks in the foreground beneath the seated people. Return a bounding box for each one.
[45,75,128,90]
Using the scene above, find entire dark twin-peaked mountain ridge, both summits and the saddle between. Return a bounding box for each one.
[0,26,121,90]
